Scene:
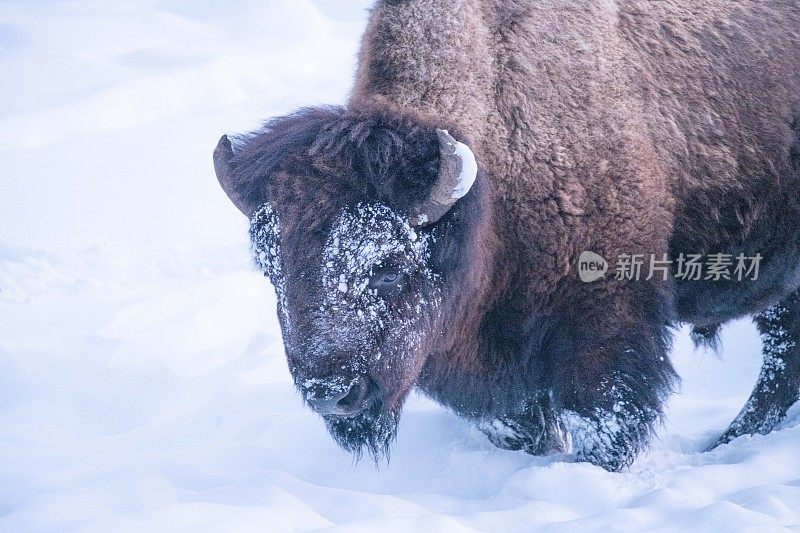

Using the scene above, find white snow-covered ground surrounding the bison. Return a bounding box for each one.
[0,0,800,532]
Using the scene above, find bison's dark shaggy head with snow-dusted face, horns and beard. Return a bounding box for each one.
[214,108,480,459]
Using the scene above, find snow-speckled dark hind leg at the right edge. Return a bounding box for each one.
[713,292,800,448]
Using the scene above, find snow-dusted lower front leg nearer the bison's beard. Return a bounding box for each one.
[479,394,567,455]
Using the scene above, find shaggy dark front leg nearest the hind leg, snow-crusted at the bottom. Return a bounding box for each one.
[555,282,675,471]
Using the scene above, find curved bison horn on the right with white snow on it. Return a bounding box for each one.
[411,130,478,226]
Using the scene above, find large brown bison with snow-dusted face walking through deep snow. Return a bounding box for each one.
[214,0,800,471]
